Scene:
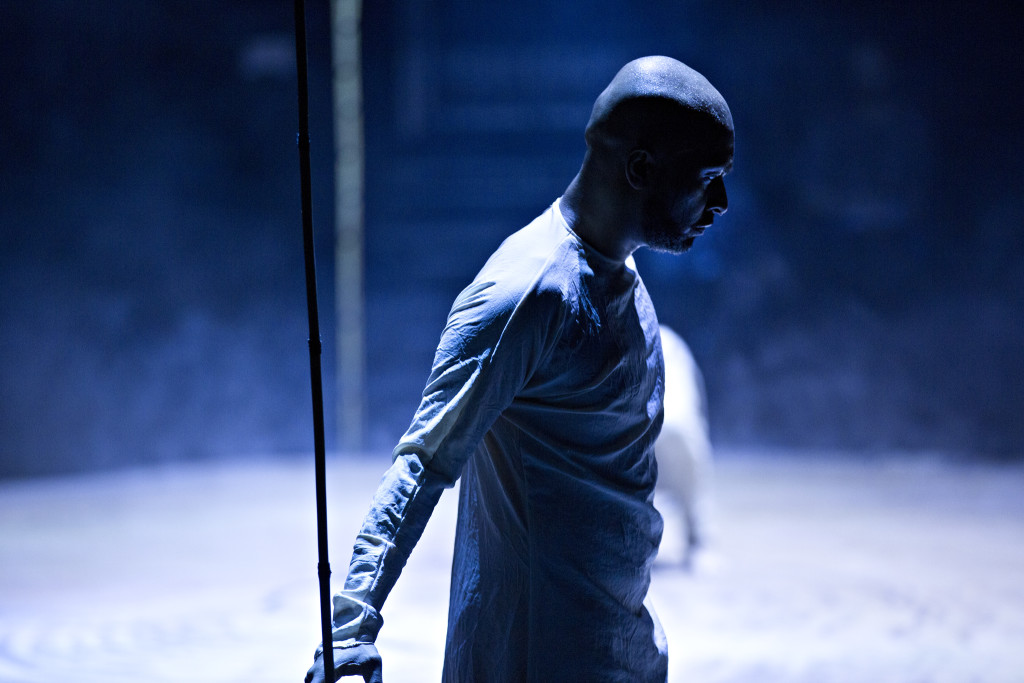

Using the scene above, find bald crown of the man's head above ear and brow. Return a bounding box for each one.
[586,56,732,157]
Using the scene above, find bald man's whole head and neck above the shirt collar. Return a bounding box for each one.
[559,56,735,259]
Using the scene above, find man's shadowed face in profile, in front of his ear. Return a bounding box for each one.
[642,130,733,254]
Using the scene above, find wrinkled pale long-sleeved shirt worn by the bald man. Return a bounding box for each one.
[323,203,667,683]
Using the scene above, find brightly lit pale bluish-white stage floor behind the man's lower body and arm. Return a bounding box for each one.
[0,453,1024,683]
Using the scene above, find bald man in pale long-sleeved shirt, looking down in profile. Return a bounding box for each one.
[306,57,733,683]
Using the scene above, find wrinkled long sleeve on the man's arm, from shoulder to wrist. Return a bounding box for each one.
[319,282,561,647]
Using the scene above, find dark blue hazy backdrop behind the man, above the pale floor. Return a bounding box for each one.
[0,0,1024,476]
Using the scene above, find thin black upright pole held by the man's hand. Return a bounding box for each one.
[295,0,334,681]
